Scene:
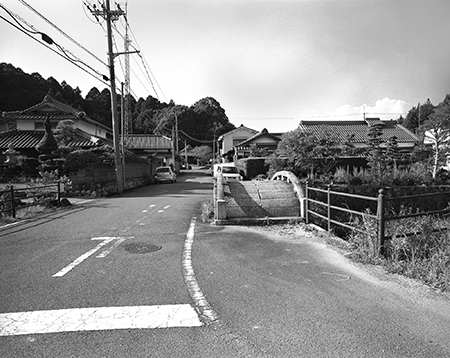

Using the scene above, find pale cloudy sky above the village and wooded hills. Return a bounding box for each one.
[0,0,450,132]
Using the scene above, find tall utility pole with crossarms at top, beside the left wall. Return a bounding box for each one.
[92,0,124,194]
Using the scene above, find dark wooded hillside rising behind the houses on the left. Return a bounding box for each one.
[0,63,235,147]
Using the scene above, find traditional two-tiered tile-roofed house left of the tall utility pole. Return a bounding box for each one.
[0,95,112,163]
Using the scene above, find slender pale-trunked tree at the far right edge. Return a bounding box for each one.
[422,94,450,178]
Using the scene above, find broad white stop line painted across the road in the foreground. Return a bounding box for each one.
[0,304,203,336]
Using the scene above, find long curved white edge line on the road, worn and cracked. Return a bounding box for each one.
[182,217,218,323]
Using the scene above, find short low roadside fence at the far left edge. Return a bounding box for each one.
[0,182,61,218]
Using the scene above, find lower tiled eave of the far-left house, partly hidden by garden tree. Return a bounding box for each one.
[0,129,108,150]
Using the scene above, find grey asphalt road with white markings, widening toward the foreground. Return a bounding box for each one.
[0,171,450,357]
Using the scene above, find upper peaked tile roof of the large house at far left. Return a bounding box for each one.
[2,95,112,132]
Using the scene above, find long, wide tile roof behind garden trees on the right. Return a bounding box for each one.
[299,118,419,143]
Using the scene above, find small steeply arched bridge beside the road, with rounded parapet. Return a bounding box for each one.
[214,171,304,225]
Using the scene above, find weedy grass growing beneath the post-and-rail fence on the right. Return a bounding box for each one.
[349,211,450,291]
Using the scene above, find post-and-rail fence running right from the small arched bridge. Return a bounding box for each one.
[305,184,450,253]
